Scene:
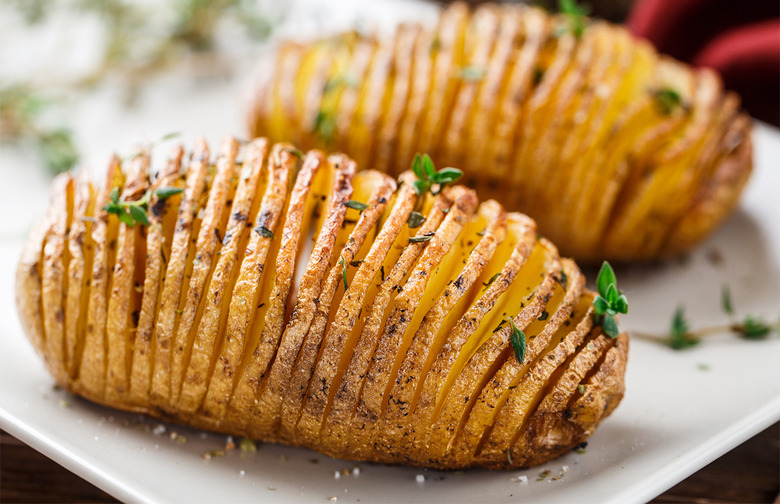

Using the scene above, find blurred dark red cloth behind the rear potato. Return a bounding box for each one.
[627,0,780,126]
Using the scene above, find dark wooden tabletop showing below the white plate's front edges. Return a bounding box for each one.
[0,423,780,504]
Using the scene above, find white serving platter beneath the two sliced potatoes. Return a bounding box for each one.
[0,2,780,504]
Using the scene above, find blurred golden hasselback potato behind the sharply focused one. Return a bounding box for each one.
[248,3,752,261]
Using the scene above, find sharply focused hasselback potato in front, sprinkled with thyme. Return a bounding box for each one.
[16,138,628,468]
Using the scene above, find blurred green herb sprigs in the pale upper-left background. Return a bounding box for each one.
[0,0,272,173]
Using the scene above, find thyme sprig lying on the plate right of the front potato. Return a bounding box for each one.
[631,286,780,350]
